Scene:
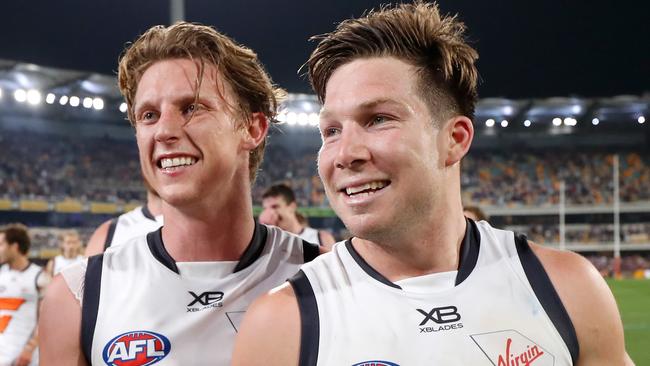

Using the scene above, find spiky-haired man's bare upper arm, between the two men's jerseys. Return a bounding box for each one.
[232,283,300,366]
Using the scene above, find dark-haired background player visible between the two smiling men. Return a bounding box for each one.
[259,184,336,248]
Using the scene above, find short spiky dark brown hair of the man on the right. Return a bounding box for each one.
[307,1,478,119]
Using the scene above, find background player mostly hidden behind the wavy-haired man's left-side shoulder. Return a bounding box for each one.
[85,184,163,257]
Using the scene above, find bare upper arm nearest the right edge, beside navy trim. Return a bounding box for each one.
[531,244,632,366]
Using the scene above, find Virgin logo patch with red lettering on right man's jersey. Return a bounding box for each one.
[470,330,555,366]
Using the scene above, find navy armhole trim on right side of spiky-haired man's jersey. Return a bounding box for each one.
[515,233,580,364]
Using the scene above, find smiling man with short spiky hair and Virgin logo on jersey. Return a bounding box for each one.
[233,1,631,366]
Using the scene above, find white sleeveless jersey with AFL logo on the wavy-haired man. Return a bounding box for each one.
[63,225,318,366]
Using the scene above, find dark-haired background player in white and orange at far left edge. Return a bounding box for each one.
[0,224,47,366]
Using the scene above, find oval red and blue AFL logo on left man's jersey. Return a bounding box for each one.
[102,330,171,366]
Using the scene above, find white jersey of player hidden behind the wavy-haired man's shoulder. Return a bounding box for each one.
[104,205,163,250]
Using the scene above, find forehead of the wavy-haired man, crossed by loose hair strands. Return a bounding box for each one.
[135,59,229,107]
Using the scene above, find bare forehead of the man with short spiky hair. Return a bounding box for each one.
[324,57,425,112]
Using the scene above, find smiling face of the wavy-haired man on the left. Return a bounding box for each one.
[134,59,254,207]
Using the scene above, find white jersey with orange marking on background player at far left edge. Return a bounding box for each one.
[0,263,41,366]
